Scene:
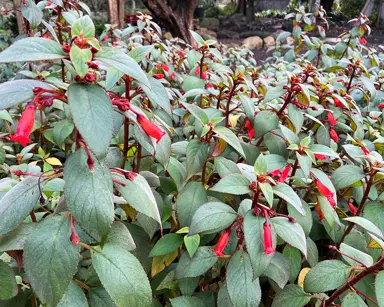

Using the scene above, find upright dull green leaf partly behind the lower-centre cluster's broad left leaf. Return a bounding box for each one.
[176,181,208,226]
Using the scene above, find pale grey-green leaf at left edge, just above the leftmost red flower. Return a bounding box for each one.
[0,79,54,110]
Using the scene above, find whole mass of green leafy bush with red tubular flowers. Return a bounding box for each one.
[0,0,384,307]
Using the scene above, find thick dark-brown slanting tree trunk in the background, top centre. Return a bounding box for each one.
[143,0,198,44]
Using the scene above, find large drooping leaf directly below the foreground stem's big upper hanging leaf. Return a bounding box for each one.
[64,148,114,240]
